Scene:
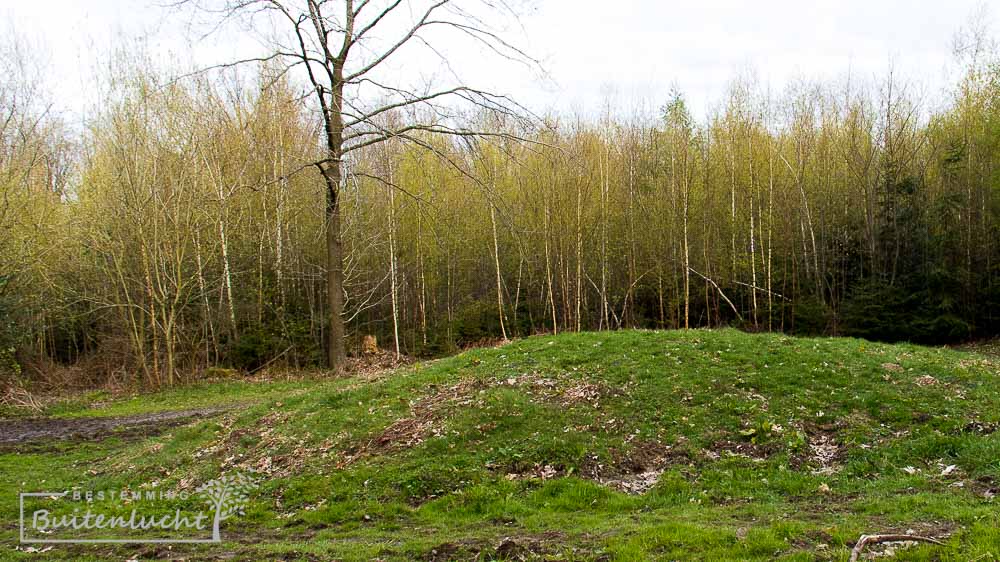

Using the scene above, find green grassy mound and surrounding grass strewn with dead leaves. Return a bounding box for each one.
[0,330,1000,560]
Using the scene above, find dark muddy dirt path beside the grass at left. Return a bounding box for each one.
[0,408,226,447]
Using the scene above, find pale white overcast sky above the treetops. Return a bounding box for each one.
[0,0,993,122]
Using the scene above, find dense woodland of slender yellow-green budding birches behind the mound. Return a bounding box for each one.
[0,28,1000,386]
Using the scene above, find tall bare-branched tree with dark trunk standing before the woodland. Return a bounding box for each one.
[180,0,539,368]
